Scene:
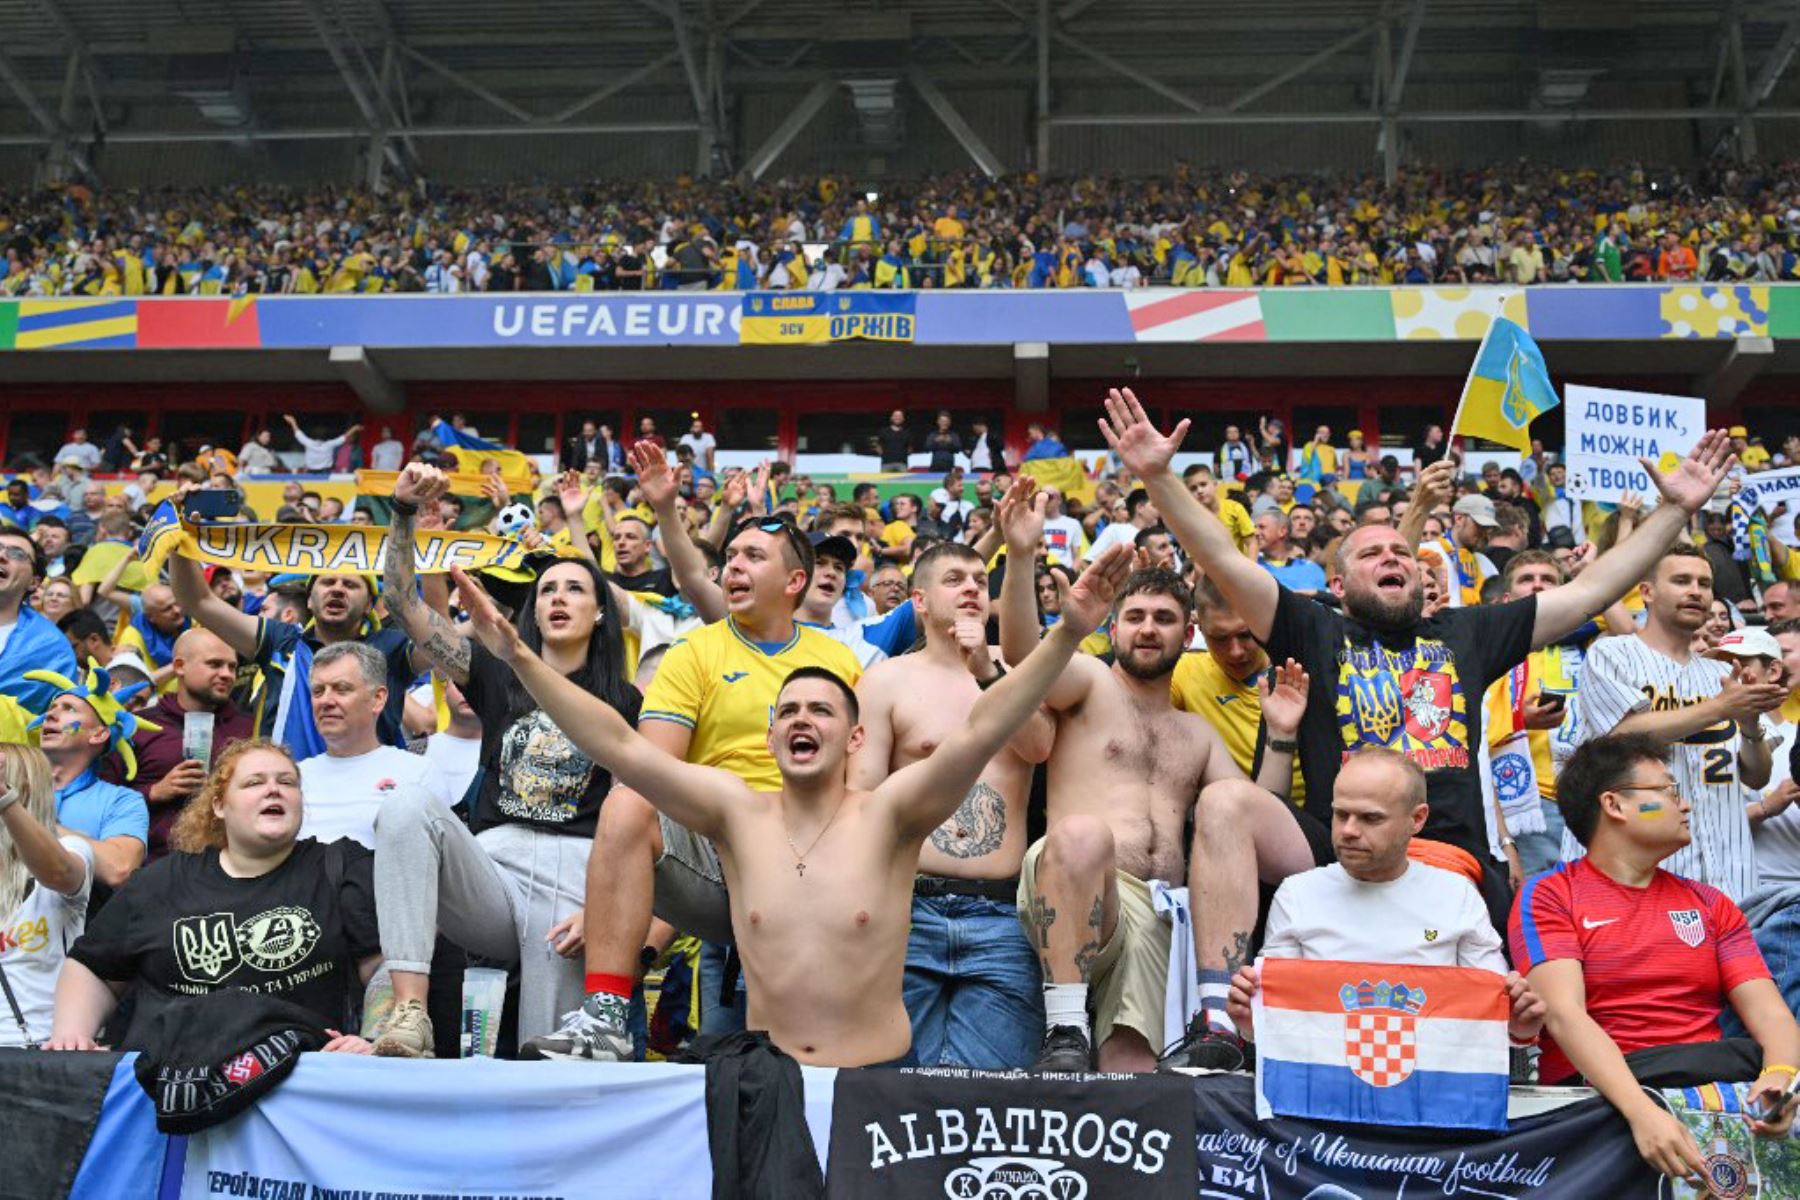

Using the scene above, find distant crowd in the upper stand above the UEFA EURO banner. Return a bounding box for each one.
[10,162,1800,297]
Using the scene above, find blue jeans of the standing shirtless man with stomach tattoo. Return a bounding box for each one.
[904,896,1044,1070]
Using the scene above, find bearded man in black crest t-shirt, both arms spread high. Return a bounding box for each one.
[1102,390,1735,1069]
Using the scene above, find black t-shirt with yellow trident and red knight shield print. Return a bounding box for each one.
[1269,588,1537,862]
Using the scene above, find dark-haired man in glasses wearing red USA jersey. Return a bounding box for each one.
[1508,737,1800,1180]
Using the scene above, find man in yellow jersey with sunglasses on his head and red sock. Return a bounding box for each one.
[522,507,862,1061]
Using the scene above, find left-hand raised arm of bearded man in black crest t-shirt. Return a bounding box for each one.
[1100,389,1280,642]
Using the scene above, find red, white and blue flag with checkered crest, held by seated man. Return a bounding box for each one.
[1251,959,1508,1130]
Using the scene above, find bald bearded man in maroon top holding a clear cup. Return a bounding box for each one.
[106,626,256,862]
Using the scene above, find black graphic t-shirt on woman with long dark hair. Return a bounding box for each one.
[463,640,641,838]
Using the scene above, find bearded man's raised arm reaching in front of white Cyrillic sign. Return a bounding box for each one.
[1532,430,1737,649]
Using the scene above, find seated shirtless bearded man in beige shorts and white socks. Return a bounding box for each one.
[999,488,1307,1070]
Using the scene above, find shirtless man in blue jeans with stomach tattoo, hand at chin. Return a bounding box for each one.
[850,542,1055,1070]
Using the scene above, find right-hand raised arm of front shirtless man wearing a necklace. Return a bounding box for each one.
[875,545,1134,837]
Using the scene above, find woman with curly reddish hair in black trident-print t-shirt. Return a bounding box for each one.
[49,741,382,1054]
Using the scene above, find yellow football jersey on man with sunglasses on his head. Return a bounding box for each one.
[639,617,862,792]
